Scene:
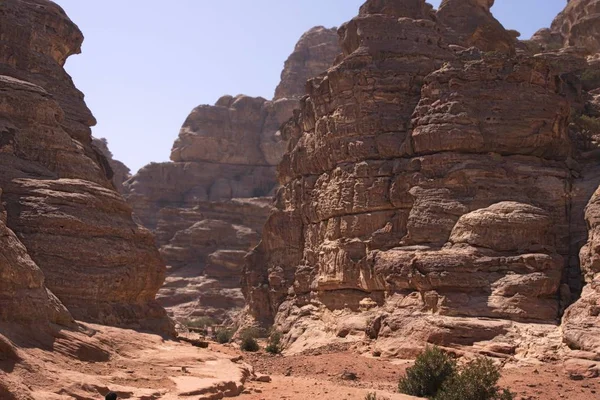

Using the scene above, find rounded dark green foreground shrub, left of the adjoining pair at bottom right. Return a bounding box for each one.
[398,347,456,398]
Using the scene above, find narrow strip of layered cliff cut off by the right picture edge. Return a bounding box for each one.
[532,0,600,359]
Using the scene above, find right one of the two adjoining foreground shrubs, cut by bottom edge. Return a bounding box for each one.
[435,357,513,400]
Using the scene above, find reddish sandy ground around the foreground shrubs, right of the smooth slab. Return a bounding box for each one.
[182,332,600,400]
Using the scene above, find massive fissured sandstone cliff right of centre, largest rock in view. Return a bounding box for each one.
[243,0,600,356]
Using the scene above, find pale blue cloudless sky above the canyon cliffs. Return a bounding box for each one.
[54,0,566,172]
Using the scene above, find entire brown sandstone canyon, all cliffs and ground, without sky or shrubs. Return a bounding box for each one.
[0,0,600,400]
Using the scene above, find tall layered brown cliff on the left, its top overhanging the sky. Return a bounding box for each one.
[0,0,170,332]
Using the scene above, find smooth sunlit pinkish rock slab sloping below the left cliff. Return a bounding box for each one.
[0,324,254,400]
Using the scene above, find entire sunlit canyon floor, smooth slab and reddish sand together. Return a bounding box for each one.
[0,324,600,400]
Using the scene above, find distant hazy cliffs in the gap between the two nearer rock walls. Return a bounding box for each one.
[125,27,340,322]
